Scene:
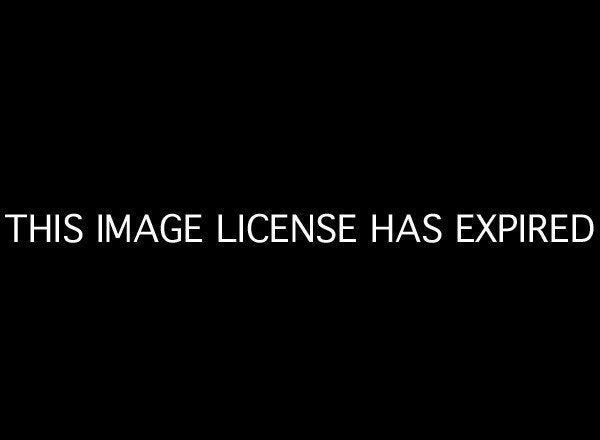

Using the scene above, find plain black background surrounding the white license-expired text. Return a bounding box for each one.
[1,5,598,433]
